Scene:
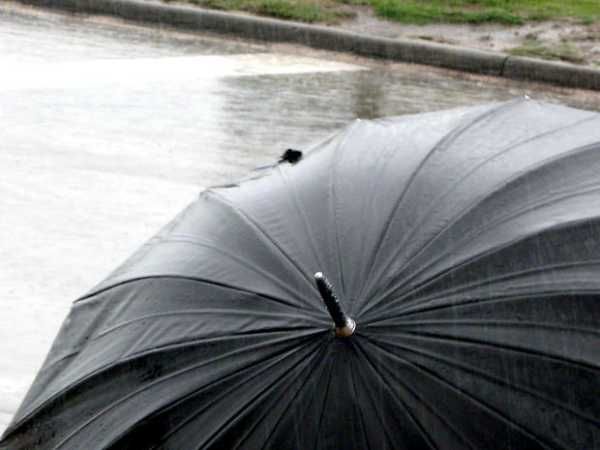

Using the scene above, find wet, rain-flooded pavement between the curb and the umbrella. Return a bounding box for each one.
[0,2,600,430]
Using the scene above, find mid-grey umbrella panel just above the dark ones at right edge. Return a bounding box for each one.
[368,141,600,304]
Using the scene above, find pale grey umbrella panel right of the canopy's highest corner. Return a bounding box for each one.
[356,102,600,302]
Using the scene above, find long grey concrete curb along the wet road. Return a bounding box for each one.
[14,0,600,90]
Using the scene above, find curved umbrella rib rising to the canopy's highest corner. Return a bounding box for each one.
[359,101,517,298]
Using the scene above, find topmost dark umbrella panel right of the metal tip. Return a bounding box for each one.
[363,216,600,326]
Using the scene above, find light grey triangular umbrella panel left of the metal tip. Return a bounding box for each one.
[88,192,324,310]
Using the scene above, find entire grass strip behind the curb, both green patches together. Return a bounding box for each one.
[164,0,600,25]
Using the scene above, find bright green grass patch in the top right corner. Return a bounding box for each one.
[371,0,600,25]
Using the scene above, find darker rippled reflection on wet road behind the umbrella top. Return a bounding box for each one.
[212,64,600,173]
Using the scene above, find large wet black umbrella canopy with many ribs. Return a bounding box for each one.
[0,100,600,450]
